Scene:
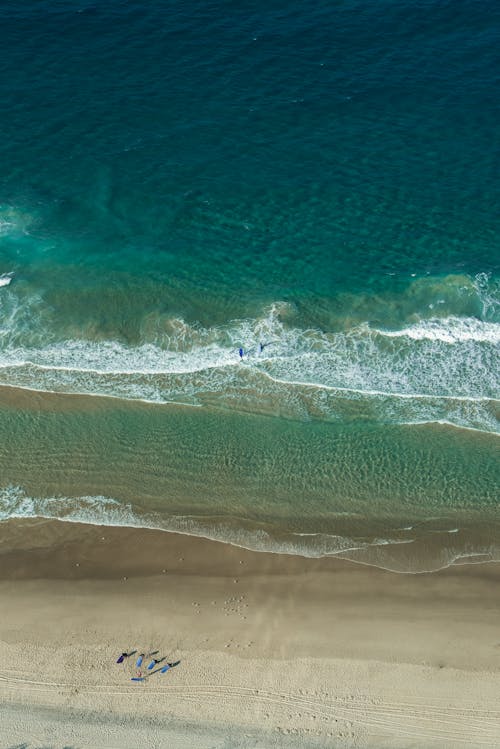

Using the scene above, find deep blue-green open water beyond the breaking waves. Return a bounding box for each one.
[0,0,500,298]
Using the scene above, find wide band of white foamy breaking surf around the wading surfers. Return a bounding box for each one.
[0,282,500,432]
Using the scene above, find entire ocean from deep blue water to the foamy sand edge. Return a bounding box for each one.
[0,0,500,572]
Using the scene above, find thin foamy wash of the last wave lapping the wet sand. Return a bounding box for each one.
[0,486,499,573]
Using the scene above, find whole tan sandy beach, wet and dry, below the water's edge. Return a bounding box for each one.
[0,520,500,749]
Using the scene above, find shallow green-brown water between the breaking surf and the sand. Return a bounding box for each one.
[0,380,500,572]
